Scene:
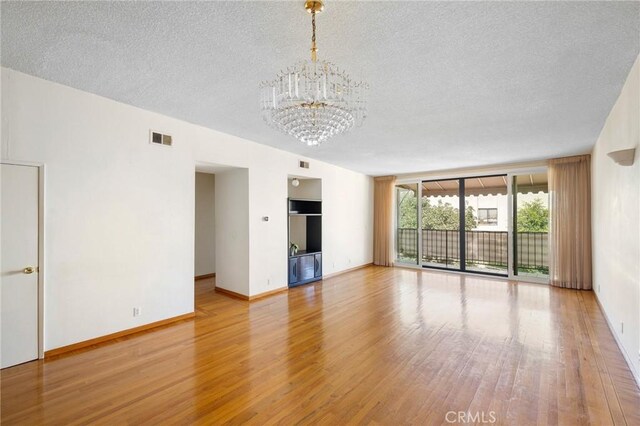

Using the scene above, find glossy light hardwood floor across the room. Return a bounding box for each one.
[2,267,640,425]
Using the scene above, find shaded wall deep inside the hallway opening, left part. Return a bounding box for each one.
[194,173,216,277]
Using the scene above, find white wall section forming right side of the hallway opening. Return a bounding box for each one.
[215,169,250,294]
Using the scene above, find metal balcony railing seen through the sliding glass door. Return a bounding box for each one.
[396,228,549,271]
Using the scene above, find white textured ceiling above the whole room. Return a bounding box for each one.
[1,1,640,175]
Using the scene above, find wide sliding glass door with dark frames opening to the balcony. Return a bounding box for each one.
[396,169,549,281]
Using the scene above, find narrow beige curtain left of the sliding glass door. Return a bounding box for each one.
[373,176,396,266]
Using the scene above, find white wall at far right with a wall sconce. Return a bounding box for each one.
[592,58,640,383]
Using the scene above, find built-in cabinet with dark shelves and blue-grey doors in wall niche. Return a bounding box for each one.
[287,198,322,287]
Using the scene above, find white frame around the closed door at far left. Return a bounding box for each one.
[0,160,46,359]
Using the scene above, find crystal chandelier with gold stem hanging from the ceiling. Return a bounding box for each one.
[260,0,369,146]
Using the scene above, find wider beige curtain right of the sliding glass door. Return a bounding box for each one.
[549,155,591,290]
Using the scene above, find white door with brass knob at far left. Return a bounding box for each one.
[0,164,39,368]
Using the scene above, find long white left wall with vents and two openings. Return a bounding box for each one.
[2,68,373,350]
